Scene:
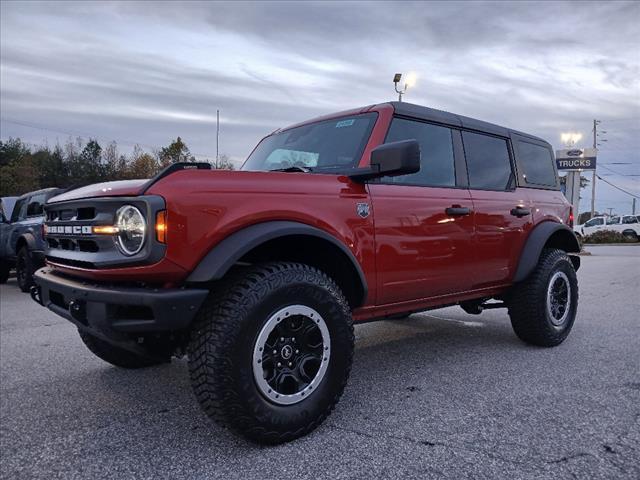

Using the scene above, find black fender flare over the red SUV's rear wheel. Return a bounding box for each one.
[513,221,580,282]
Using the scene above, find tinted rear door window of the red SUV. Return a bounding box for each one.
[462,132,513,190]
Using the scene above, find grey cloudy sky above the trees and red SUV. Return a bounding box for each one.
[0,1,640,213]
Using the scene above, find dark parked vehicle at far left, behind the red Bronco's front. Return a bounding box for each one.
[2,188,63,292]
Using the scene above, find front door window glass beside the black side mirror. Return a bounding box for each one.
[382,118,456,187]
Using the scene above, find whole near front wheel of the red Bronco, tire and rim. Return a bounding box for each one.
[189,262,354,444]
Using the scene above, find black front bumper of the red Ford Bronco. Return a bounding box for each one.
[31,267,209,343]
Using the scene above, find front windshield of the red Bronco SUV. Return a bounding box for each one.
[242,113,377,173]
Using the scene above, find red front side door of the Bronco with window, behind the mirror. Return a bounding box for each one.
[369,118,473,304]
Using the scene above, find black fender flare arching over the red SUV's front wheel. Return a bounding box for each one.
[187,221,368,302]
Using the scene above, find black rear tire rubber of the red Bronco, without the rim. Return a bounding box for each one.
[508,249,578,347]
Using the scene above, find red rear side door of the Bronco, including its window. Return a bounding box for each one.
[462,131,533,288]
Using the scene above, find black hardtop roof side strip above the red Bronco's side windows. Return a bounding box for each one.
[389,102,549,144]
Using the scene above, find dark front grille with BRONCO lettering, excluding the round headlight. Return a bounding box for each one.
[45,195,165,269]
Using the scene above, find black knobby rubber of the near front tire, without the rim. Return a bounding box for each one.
[188,262,354,444]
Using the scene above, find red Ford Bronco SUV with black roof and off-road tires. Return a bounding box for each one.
[31,103,579,443]
